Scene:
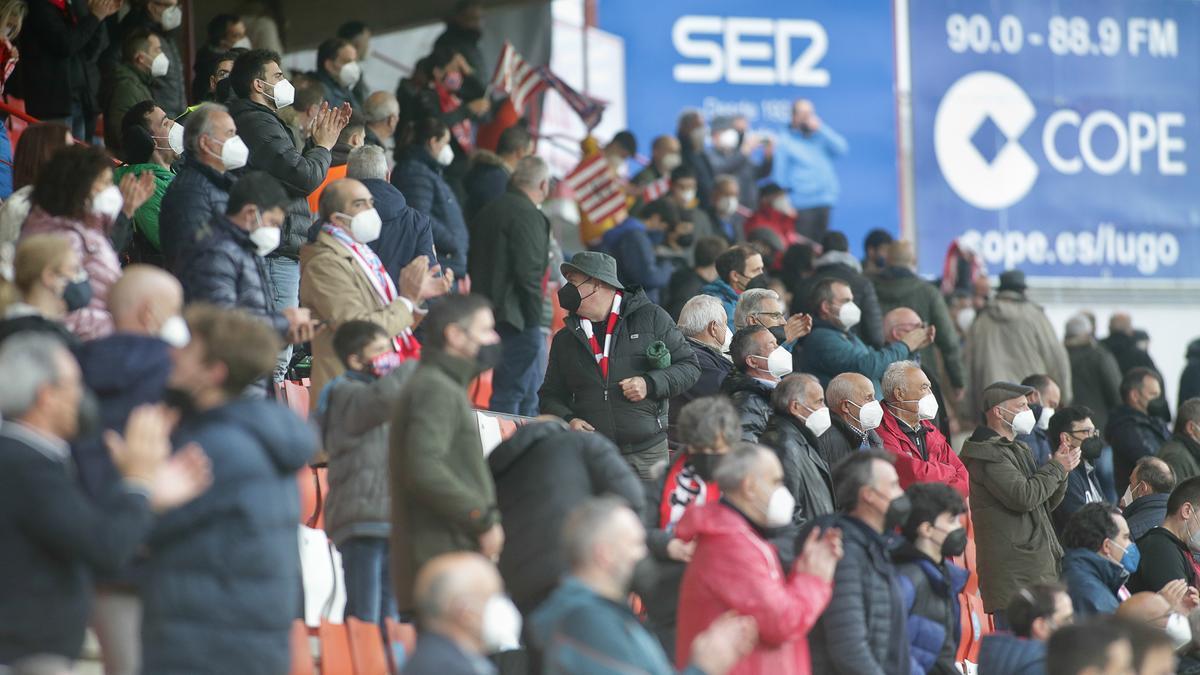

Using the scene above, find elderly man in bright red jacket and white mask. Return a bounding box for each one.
[878,362,971,497]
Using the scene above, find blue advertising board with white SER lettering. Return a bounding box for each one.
[598,0,900,251]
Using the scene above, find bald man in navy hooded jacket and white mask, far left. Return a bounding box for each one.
[71,265,190,673]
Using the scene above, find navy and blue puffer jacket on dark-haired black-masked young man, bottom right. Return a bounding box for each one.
[892,542,967,675]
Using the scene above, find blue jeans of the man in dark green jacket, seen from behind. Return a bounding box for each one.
[488,322,546,417]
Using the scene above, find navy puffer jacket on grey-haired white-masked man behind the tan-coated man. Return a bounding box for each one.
[158,154,234,274]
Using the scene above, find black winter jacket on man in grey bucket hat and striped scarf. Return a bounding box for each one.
[539,288,700,454]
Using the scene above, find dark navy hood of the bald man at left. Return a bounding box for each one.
[78,333,170,399]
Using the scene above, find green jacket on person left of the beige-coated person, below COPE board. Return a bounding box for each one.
[871,267,966,389]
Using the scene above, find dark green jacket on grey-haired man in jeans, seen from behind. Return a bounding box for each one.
[468,187,550,330]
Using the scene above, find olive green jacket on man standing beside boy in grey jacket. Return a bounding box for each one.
[389,348,500,611]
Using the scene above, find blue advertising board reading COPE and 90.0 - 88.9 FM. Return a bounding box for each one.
[908,0,1200,280]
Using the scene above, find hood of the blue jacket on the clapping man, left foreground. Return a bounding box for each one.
[193,399,317,473]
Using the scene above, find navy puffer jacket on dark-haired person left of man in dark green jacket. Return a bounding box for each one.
[391,145,470,279]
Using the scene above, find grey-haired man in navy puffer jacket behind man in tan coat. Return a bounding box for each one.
[158,103,243,267]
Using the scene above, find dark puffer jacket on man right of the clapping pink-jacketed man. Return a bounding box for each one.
[798,514,910,675]
